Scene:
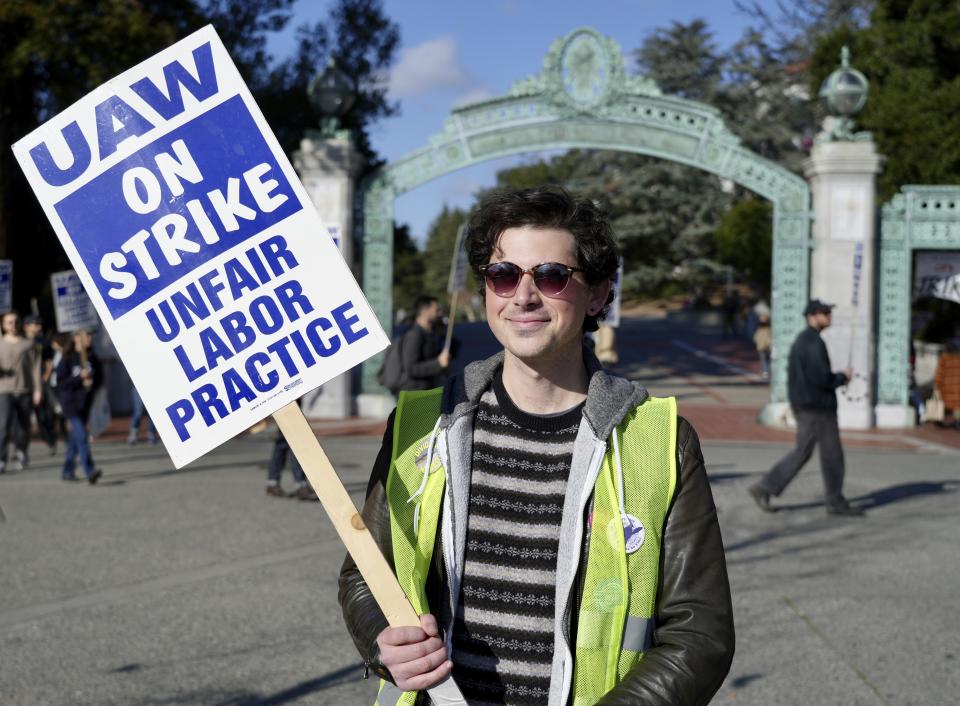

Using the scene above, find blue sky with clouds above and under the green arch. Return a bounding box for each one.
[270,0,775,240]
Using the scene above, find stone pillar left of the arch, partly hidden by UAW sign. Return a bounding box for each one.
[293,131,362,418]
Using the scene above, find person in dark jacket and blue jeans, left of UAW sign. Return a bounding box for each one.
[56,329,103,485]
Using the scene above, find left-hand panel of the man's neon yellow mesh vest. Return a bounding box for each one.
[376,388,447,706]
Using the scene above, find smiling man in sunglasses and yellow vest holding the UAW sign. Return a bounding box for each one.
[340,188,734,706]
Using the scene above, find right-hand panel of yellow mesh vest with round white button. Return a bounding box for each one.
[573,397,677,706]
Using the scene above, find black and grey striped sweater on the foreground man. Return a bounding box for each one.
[452,373,583,706]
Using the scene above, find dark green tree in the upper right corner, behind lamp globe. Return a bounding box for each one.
[810,0,960,200]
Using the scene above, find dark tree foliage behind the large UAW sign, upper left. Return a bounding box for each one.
[0,0,399,308]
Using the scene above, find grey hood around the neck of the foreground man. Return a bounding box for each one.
[440,346,649,439]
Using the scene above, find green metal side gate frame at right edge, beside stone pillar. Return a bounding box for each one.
[877,186,960,405]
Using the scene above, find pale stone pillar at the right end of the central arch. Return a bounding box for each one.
[804,141,883,429]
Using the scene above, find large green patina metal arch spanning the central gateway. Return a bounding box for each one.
[357,28,811,402]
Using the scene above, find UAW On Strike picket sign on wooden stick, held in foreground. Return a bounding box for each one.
[14,26,463,704]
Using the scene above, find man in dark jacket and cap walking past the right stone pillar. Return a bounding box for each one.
[749,299,863,517]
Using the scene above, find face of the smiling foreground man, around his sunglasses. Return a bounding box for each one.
[485,226,609,363]
